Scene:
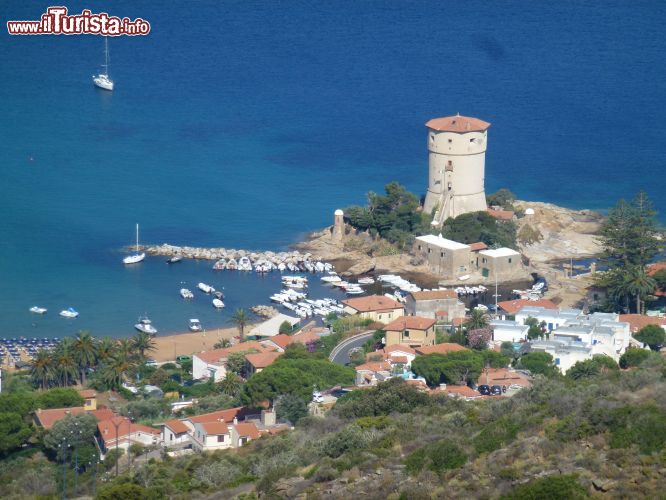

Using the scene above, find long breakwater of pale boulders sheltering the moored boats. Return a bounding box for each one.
[143,243,321,266]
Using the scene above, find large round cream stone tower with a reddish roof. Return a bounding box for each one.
[423,115,490,226]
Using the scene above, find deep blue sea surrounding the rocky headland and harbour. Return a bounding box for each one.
[0,0,666,337]
